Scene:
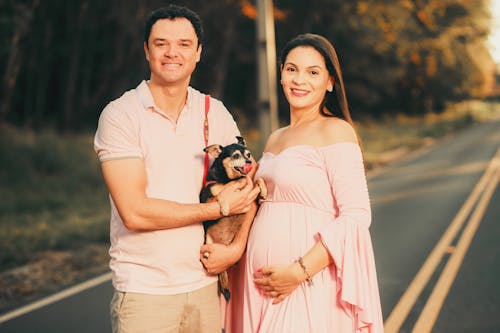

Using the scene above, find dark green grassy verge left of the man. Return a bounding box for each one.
[0,127,109,269]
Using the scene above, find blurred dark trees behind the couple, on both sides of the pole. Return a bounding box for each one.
[0,0,495,131]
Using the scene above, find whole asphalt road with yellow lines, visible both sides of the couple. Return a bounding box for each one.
[0,121,500,333]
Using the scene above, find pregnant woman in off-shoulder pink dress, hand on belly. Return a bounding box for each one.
[232,34,383,333]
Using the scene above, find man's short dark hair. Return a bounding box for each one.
[144,5,203,46]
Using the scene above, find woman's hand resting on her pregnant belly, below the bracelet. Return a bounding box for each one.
[254,263,304,304]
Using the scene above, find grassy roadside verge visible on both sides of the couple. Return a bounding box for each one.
[0,102,500,272]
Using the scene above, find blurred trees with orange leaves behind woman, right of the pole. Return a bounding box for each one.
[270,0,494,113]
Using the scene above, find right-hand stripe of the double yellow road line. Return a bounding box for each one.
[412,159,500,333]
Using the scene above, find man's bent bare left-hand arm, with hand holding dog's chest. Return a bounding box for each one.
[101,158,257,230]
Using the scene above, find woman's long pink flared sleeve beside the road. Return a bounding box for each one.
[319,143,383,333]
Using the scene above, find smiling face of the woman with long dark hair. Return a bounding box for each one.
[281,46,333,109]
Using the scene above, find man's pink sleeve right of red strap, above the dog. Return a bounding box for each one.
[209,98,241,146]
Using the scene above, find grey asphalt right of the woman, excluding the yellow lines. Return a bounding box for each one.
[369,121,500,333]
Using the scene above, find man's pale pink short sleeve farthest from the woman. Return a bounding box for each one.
[94,102,142,162]
